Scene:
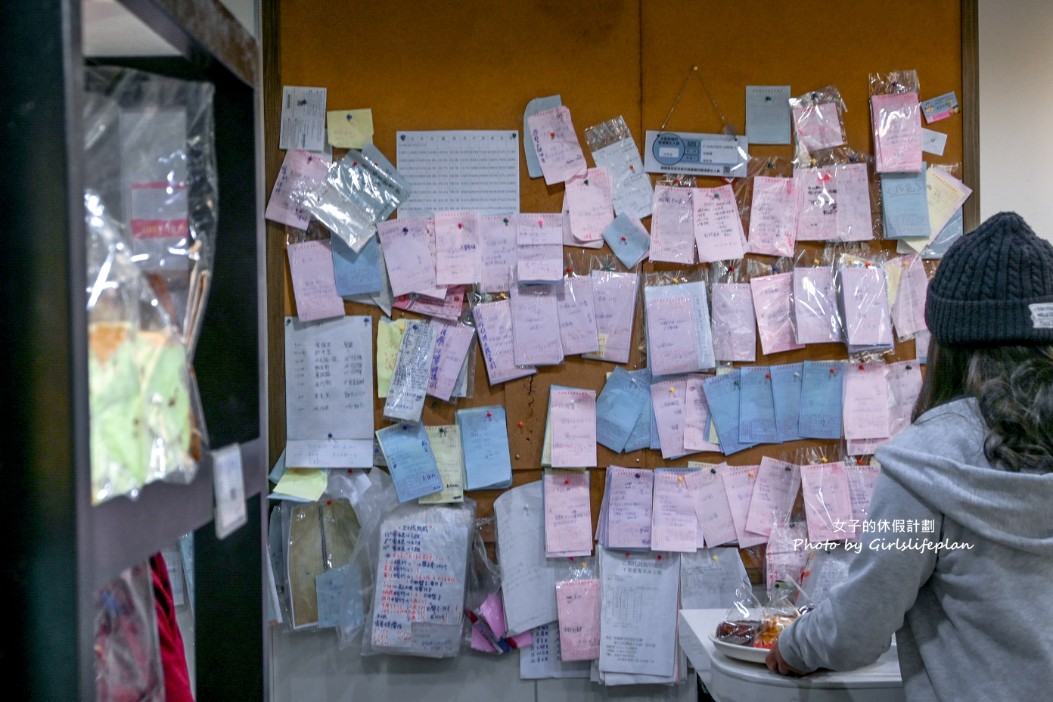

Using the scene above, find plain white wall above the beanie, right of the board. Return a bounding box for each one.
[979,0,1053,241]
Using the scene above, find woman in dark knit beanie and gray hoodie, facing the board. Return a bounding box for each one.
[767,213,1053,701]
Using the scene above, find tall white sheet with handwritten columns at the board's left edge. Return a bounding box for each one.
[285,316,373,468]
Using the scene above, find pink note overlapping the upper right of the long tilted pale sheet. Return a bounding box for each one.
[544,470,593,558]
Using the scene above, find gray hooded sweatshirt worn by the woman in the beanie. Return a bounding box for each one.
[779,399,1053,702]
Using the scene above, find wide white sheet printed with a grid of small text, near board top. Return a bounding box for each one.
[395,129,519,217]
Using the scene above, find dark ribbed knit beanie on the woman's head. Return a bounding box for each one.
[925,212,1053,345]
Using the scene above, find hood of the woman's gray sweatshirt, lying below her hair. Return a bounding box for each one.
[874,398,1053,557]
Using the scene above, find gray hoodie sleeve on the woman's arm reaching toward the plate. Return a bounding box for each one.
[779,475,942,673]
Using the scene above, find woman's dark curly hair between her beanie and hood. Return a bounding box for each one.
[913,339,1053,474]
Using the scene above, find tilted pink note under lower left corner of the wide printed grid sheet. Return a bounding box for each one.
[377,218,445,297]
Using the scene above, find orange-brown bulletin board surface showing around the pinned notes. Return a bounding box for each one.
[264,0,975,565]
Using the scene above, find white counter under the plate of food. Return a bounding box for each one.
[680,609,903,702]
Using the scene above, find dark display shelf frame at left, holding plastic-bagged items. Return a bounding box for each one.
[0,0,270,700]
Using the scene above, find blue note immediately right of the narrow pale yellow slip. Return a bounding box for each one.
[457,405,512,490]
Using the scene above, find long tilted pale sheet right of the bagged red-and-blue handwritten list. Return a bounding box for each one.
[494,484,565,635]
